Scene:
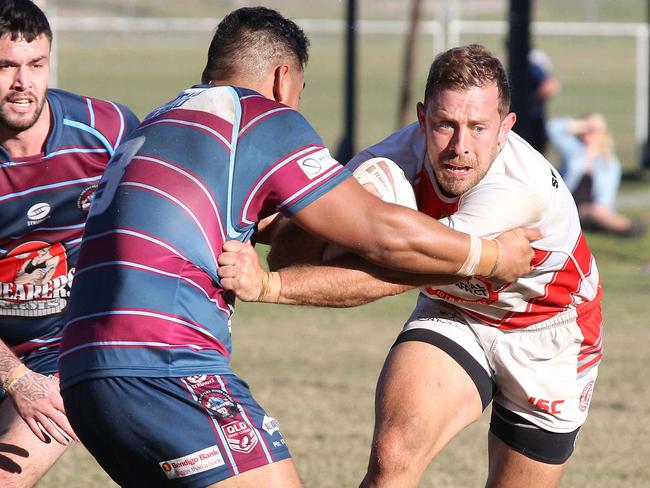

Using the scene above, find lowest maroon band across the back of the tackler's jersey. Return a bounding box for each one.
[61,309,228,357]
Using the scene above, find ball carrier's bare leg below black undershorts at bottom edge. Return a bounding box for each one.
[485,433,568,488]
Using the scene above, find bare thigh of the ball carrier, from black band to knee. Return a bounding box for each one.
[374,341,483,460]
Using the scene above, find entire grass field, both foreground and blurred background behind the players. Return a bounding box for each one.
[34,0,650,488]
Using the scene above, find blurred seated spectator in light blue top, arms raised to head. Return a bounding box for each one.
[547,113,647,237]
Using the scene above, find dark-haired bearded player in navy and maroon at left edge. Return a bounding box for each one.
[0,0,137,487]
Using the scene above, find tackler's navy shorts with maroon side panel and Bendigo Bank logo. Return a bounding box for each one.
[63,374,289,487]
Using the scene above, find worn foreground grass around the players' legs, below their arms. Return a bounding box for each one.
[39,230,650,488]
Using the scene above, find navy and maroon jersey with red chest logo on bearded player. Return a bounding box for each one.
[0,89,138,373]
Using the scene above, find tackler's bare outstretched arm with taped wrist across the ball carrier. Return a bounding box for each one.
[293,178,540,282]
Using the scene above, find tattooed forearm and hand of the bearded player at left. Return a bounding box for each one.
[0,341,78,446]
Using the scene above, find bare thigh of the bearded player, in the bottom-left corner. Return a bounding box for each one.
[0,392,65,488]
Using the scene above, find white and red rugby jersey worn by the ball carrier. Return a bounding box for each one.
[348,123,601,330]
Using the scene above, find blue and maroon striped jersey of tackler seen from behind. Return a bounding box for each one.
[59,86,350,388]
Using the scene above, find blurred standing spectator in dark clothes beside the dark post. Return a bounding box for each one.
[528,49,560,154]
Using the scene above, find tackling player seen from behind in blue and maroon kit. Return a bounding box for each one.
[59,7,535,488]
